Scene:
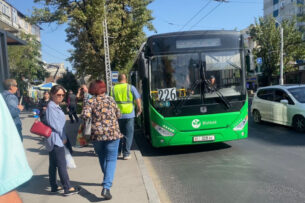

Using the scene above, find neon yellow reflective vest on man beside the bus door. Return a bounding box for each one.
[111,83,133,114]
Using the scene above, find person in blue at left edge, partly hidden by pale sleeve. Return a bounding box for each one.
[2,79,24,141]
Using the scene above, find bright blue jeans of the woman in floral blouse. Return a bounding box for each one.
[93,139,120,189]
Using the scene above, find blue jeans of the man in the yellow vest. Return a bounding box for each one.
[119,118,134,157]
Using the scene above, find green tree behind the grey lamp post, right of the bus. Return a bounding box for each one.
[249,17,305,84]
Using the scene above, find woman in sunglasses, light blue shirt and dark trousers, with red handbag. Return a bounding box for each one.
[46,85,79,196]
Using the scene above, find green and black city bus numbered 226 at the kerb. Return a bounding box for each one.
[129,30,248,147]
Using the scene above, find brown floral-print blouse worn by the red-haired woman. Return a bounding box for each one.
[81,95,123,141]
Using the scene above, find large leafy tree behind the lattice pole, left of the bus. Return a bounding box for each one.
[31,0,154,78]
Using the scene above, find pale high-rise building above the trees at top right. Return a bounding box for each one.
[264,0,305,29]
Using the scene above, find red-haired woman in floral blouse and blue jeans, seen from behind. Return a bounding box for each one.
[81,80,123,200]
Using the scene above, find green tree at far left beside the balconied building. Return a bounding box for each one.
[8,33,48,93]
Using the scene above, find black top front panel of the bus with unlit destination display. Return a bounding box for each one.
[145,30,243,56]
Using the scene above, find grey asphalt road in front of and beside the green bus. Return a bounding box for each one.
[136,109,305,203]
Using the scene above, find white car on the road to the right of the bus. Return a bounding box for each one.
[251,85,305,132]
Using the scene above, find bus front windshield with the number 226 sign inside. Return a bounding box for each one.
[150,50,243,101]
